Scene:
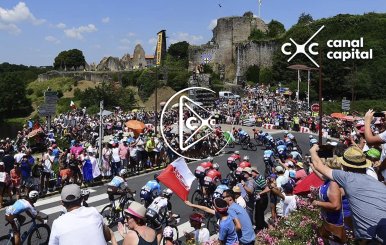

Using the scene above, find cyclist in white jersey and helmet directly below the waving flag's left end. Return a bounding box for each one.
[145,188,173,241]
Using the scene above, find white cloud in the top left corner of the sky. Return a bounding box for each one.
[0,2,45,34]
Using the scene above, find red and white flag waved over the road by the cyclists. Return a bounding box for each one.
[157,157,196,201]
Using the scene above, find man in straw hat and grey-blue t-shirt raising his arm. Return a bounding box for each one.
[310,145,386,244]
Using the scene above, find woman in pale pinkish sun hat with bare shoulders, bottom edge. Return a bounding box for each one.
[118,201,157,245]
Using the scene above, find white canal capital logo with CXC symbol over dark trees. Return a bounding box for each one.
[281,25,373,67]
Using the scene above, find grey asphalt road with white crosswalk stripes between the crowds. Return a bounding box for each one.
[0,131,328,243]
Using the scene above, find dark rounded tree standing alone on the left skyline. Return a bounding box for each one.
[54,49,86,70]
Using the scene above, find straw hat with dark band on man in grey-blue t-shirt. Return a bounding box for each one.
[337,146,371,168]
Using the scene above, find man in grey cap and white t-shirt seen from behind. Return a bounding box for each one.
[49,184,117,245]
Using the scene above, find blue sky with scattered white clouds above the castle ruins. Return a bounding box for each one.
[0,0,386,66]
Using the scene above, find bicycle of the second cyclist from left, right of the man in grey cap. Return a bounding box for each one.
[100,190,136,228]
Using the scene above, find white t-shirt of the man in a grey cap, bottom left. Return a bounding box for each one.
[49,207,106,245]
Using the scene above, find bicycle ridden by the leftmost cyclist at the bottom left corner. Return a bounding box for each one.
[0,216,51,245]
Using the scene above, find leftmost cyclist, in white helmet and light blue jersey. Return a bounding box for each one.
[5,191,44,245]
